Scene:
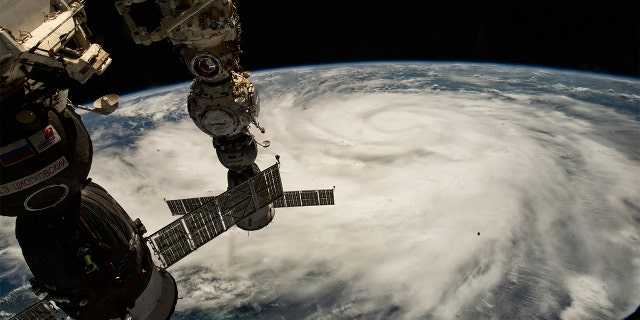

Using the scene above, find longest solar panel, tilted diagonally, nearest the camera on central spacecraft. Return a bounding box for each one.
[147,164,283,268]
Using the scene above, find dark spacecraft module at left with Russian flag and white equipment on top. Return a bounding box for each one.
[0,0,177,319]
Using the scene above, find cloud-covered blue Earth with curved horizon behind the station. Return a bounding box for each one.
[0,62,640,320]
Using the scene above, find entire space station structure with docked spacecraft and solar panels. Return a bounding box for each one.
[0,0,334,320]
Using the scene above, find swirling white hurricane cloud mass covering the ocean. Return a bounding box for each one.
[93,69,638,318]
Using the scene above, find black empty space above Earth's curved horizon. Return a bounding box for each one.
[71,0,640,103]
